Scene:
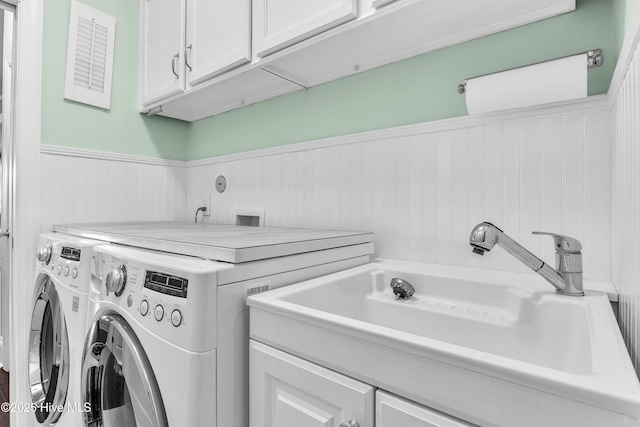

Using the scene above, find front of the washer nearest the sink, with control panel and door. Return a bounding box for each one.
[81,245,225,427]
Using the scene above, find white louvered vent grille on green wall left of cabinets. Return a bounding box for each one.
[64,1,115,109]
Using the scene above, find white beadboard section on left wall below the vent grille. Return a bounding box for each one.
[40,146,187,231]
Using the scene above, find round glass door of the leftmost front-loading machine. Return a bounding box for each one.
[29,274,69,425]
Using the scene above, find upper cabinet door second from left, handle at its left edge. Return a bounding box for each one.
[185,0,251,85]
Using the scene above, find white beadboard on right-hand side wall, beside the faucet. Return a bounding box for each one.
[603,30,640,375]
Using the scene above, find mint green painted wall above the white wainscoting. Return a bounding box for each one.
[42,0,637,160]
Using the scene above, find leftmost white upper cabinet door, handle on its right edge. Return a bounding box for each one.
[139,0,185,105]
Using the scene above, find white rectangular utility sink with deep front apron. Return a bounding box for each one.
[248,260,640,427]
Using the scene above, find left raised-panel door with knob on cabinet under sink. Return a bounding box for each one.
[249,340,374,427]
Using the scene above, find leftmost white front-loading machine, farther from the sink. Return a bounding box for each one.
[29,233,104,427]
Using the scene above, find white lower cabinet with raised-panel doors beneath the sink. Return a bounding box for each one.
[249,340,472,427]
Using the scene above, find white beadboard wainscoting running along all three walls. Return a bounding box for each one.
[41,93,640,372]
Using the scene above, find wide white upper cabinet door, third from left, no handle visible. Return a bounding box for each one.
[253,0,358,57]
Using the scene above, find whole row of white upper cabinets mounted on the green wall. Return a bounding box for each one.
[139,0,576,121]
